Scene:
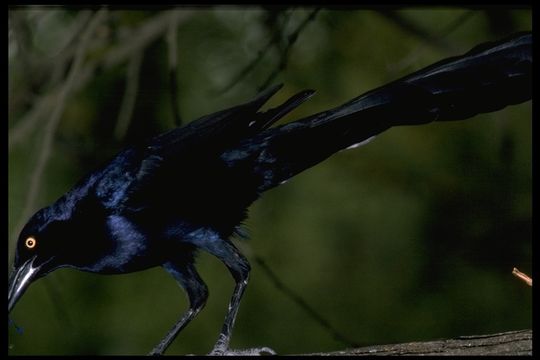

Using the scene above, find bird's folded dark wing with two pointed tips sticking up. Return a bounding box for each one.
[91,85,314,212]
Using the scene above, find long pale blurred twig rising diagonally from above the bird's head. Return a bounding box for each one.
[10,8,107,250]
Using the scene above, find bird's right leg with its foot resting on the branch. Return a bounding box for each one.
[204,240,276,355]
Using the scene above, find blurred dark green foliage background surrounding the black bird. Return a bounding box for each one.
[8,7,532,355]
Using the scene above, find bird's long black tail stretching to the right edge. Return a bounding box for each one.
[223,33,532,193]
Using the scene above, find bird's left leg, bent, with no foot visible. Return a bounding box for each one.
[148,262,208,355]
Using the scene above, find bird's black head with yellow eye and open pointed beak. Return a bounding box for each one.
[8,209,73,313]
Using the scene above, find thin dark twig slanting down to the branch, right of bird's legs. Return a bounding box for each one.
[254,256,358,347]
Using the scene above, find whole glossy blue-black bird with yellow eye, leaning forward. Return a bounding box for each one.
[8,33,532,354]
